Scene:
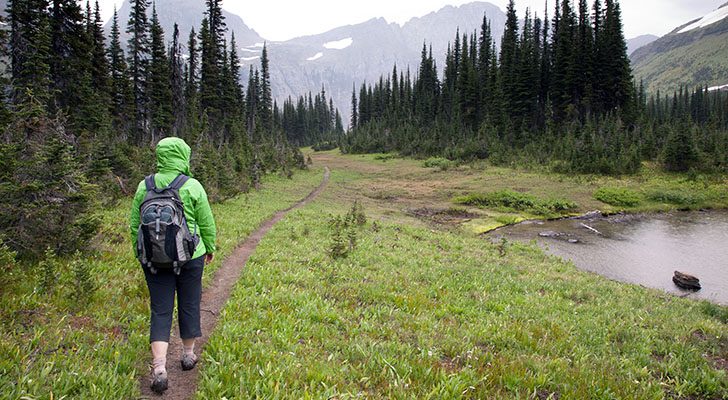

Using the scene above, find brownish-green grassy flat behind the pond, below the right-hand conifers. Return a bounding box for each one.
[307,150,728,234]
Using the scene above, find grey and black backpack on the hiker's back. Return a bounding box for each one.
[137,175,200,275]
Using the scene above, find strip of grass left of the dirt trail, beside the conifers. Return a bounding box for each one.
[0,169,322,399]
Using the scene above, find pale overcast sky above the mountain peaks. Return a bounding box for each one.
[99,0,728,41]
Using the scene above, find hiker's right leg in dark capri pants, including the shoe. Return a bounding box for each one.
[177,257,205,369]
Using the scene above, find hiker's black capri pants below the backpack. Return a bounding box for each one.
[142,256,205,342]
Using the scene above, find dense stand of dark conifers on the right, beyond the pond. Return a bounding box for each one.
[341,0,728,174]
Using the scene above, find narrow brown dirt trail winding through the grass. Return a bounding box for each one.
[140,168,330,400]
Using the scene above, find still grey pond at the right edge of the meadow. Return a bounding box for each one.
[489,211,728,305]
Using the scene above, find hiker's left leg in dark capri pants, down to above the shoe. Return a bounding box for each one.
[144,268,175,374]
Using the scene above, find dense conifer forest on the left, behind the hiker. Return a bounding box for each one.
[0,0,336,256]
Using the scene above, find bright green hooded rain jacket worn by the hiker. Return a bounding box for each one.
[129,138,217,258]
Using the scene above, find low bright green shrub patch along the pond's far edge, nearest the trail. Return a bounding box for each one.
[454,190,577,215]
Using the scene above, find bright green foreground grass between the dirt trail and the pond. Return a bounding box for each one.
[197,177,728,399]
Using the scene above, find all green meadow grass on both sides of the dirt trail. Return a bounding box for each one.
[5,151,728,399]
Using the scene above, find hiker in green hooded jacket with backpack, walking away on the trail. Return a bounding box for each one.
[130,138,216,394]
